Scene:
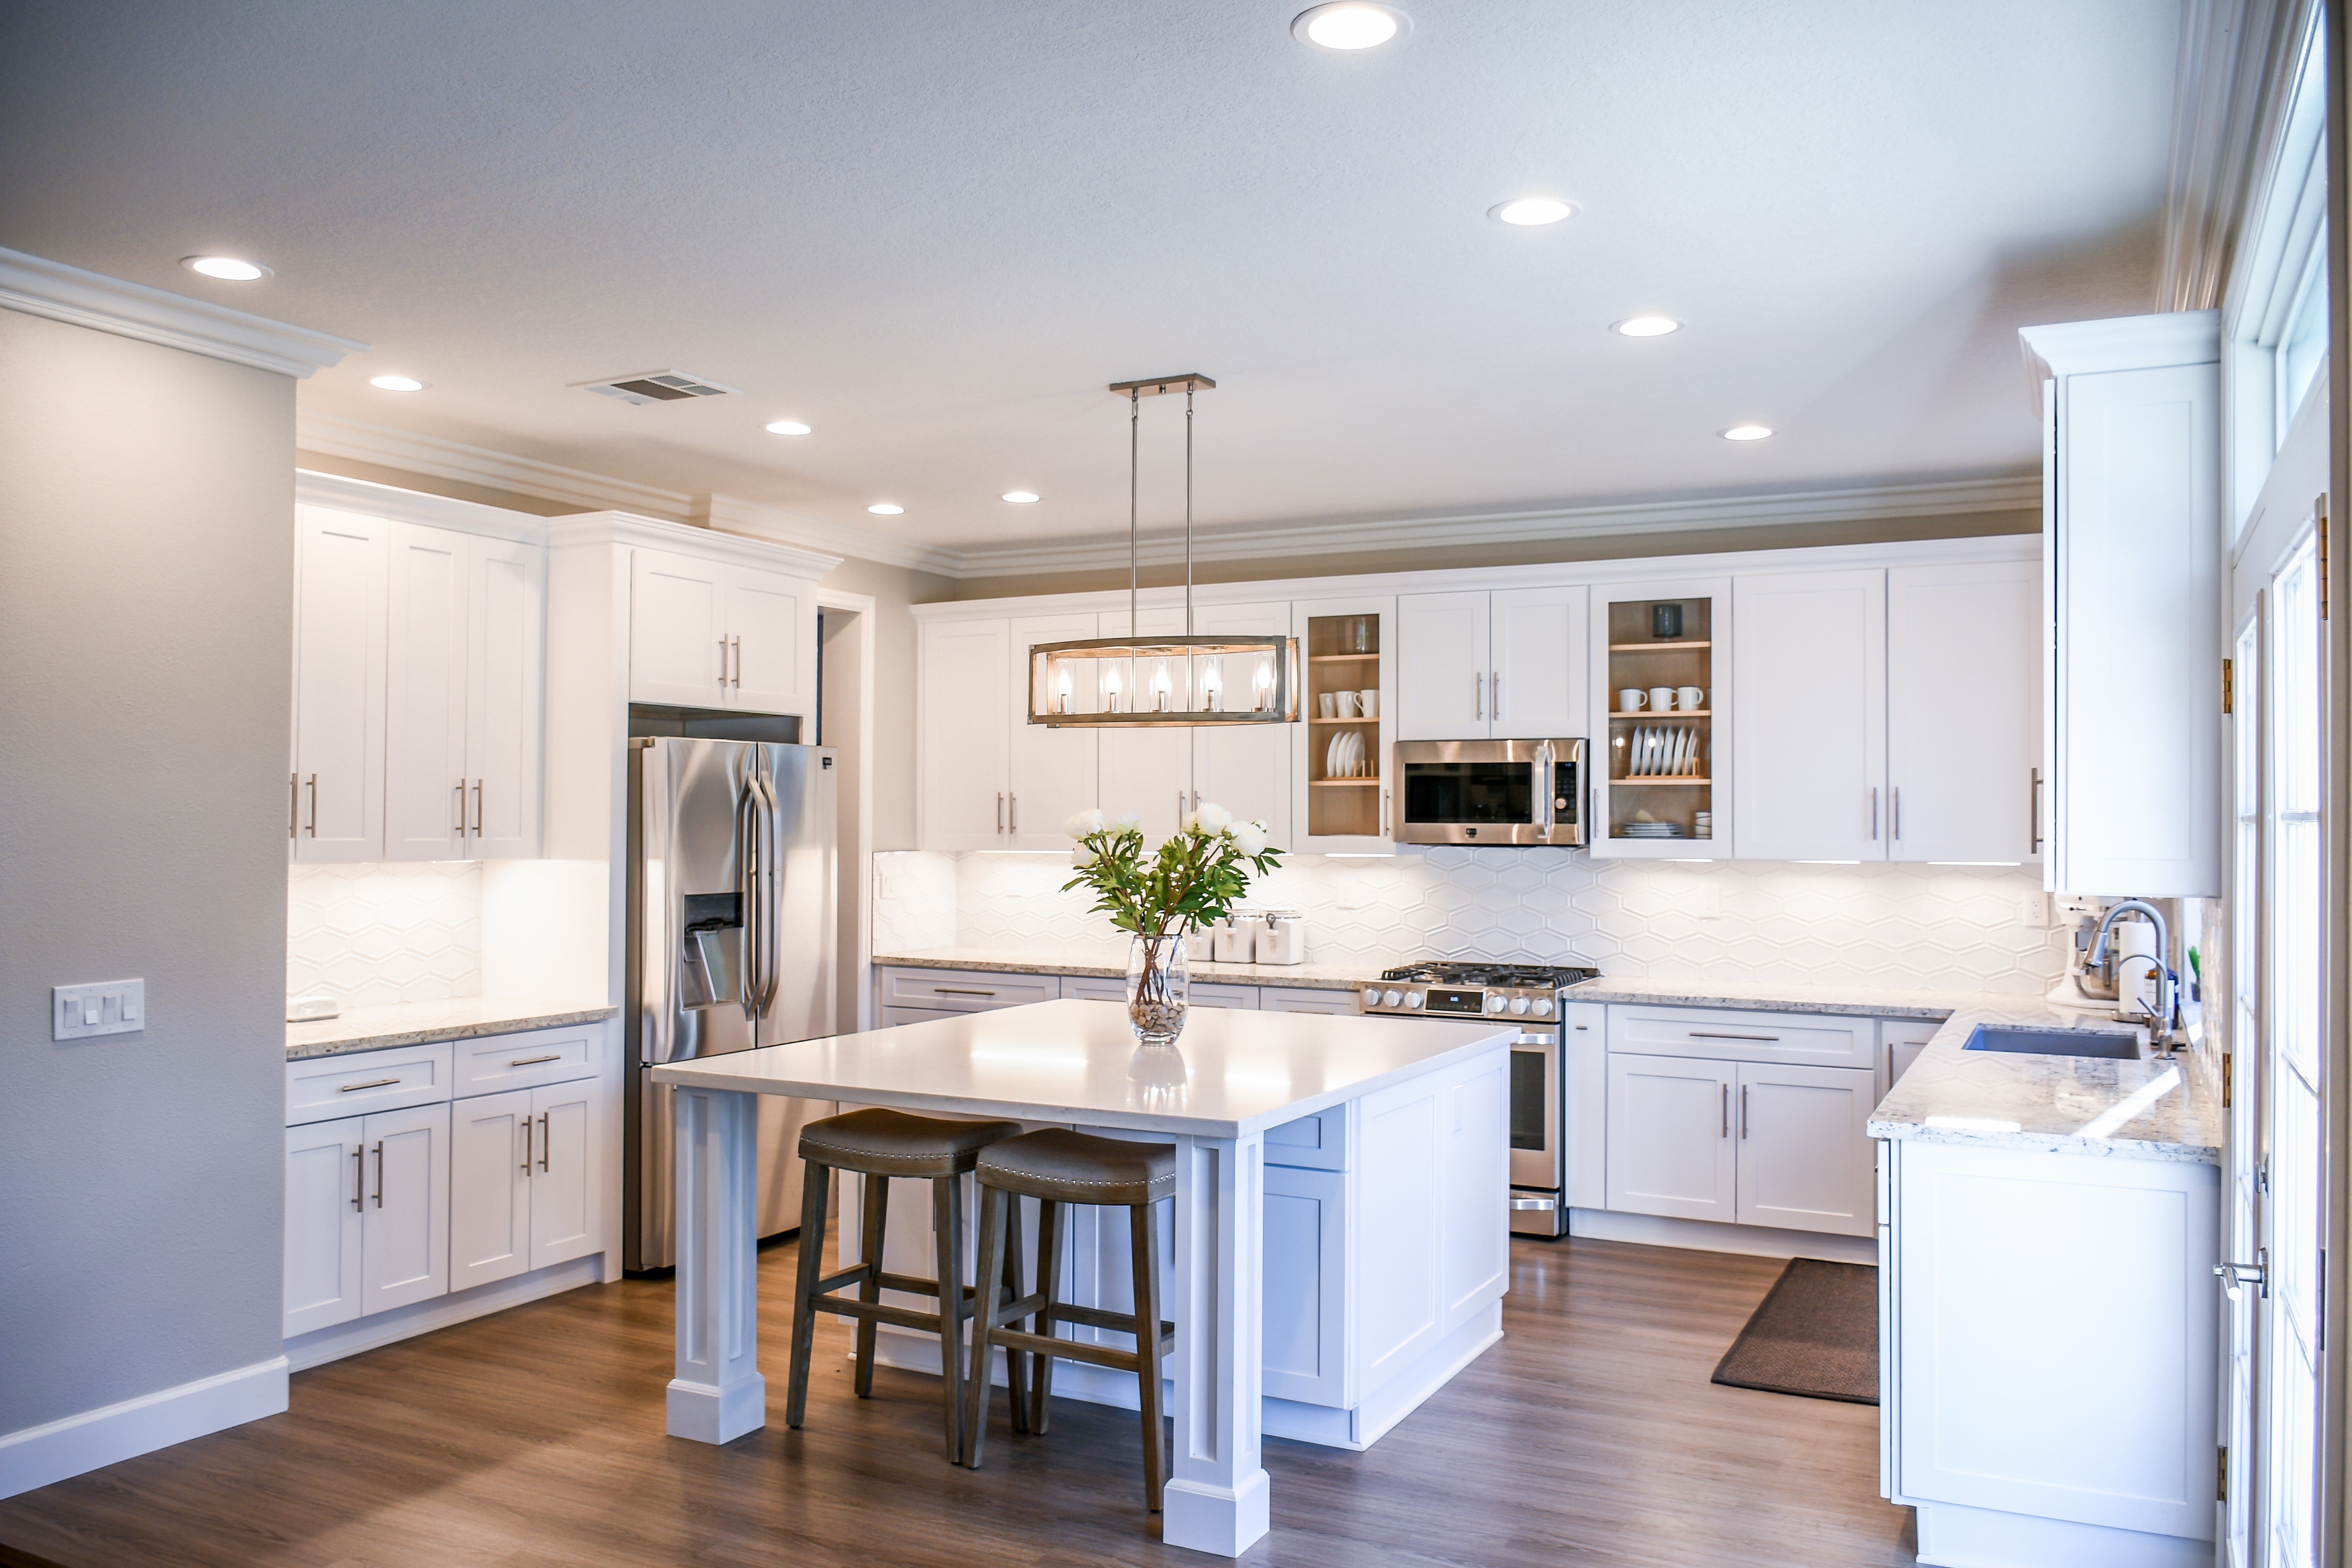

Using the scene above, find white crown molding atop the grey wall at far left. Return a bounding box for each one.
[0,249,367,379]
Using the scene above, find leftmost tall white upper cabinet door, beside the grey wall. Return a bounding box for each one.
[287,505,393,863]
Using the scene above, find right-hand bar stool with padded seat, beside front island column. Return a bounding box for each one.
[964,1126,1176,1514]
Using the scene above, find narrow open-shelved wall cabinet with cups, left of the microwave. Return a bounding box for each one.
[1291,597,1397,856]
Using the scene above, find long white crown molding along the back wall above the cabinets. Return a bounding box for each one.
[936,475,2041,578]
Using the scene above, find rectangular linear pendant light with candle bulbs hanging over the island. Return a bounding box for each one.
[1028,374,1298,729]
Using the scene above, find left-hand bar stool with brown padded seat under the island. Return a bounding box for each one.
[783,1107,1023,1464]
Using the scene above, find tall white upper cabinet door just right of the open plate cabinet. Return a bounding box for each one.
[1731,569,1889,860]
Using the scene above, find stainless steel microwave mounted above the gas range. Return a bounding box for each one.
[1395,741,1585,844]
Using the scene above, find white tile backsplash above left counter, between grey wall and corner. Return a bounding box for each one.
[287,860,482,1006]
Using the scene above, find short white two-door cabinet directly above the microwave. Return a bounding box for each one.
[1397,585,1590,741]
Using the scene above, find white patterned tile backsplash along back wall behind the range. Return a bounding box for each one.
[872,849,2063,992]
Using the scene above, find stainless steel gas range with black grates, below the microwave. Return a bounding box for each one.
[1364,964,1599,1236]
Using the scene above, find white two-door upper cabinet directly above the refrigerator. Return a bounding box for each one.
[628,548,816,717]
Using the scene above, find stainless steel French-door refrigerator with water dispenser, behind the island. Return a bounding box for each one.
[621,738,837,1269]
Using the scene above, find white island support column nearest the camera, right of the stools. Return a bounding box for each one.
[1160,1133,1270,1556]
